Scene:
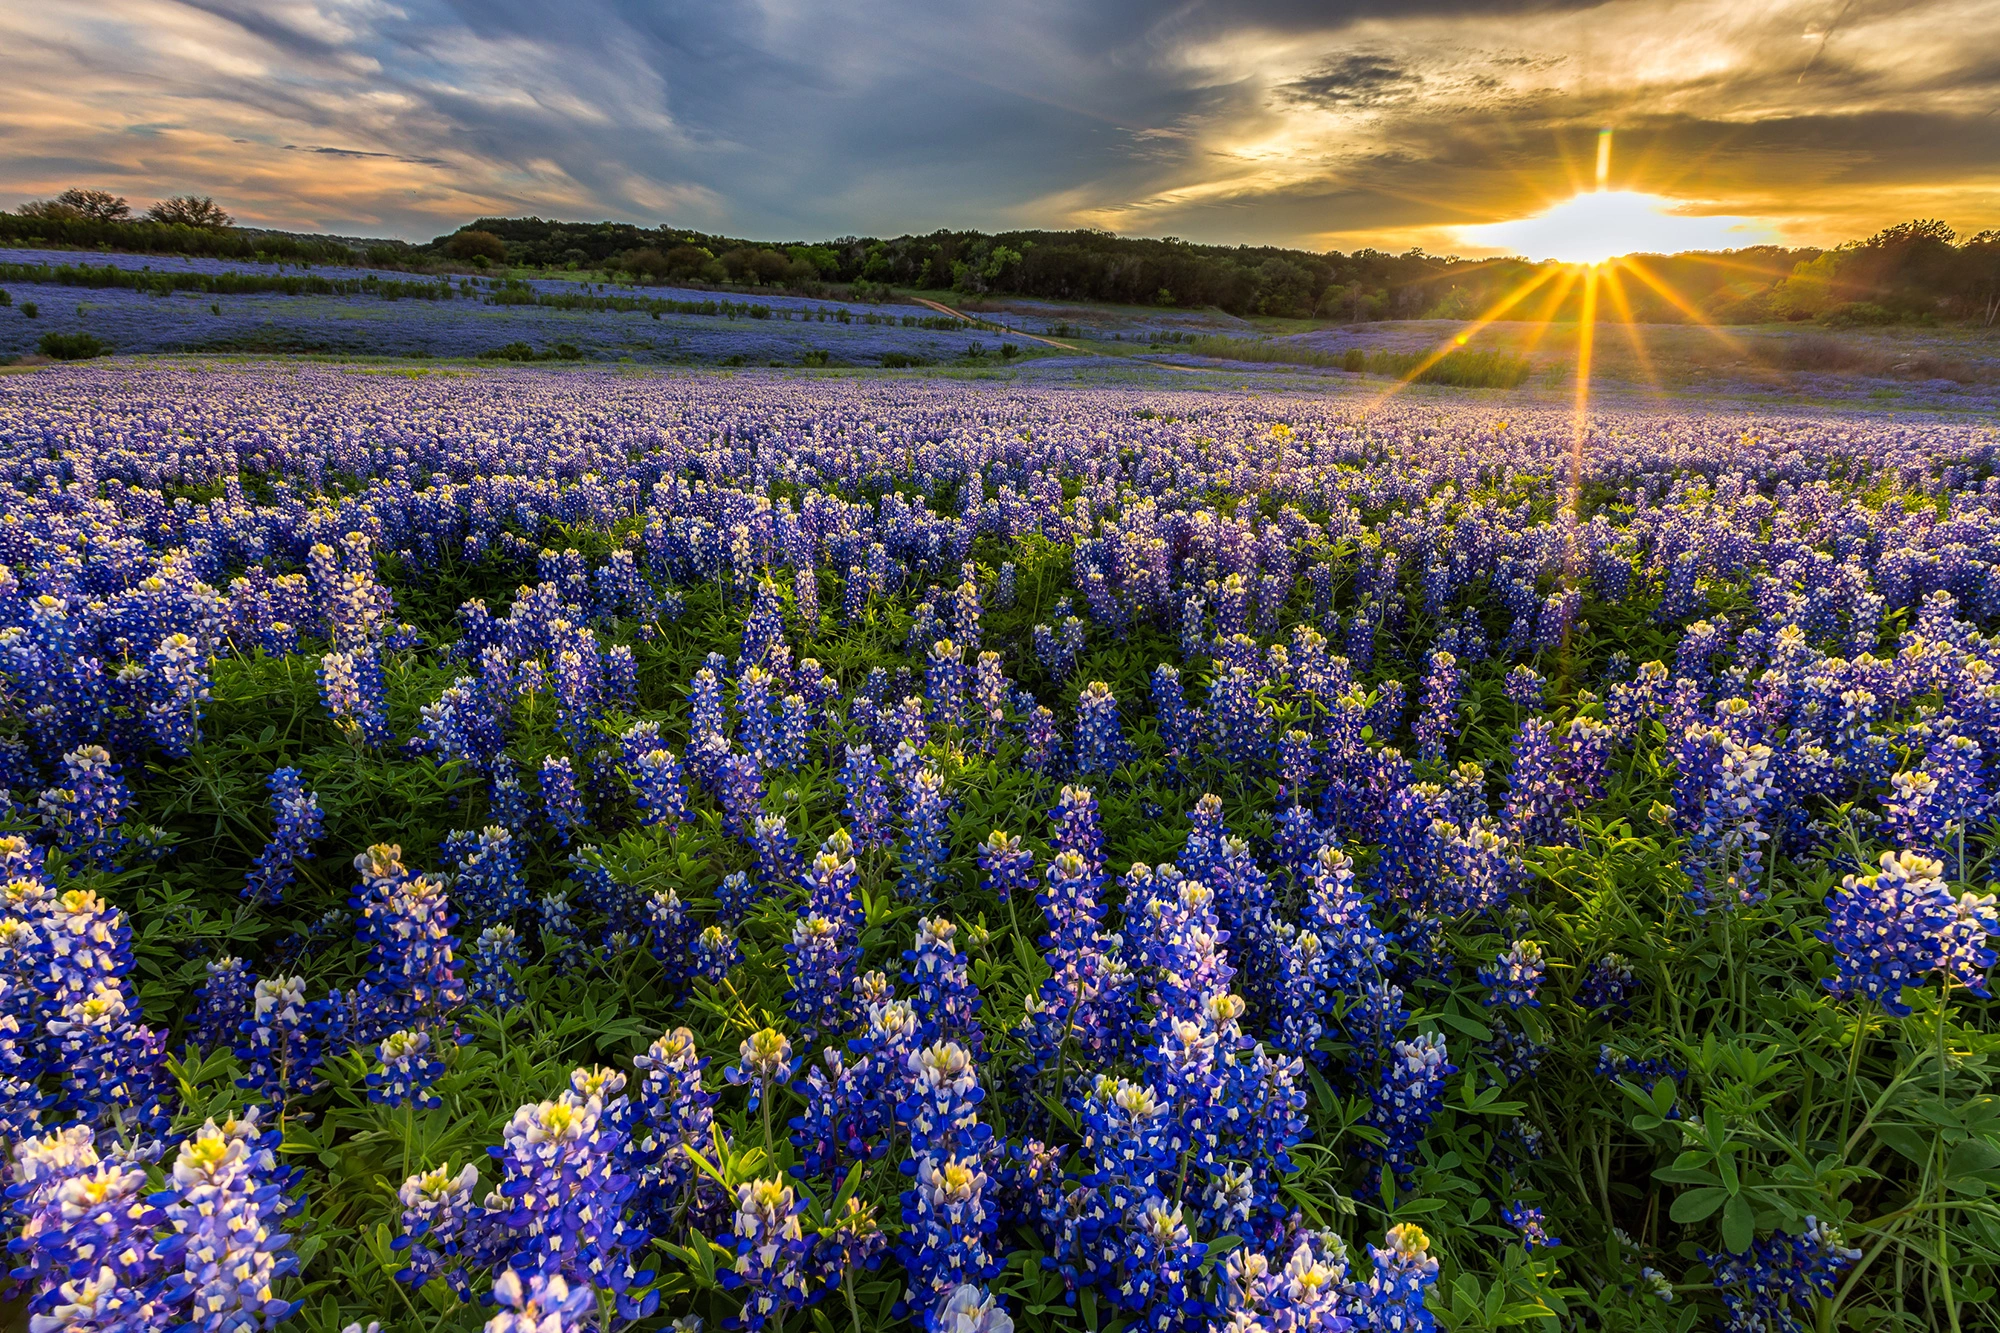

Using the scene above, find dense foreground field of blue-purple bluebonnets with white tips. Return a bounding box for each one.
[0,366,2000,1333]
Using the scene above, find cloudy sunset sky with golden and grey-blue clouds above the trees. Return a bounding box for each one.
[0,0,2000,256]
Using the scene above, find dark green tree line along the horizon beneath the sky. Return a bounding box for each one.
[0,188,2000,326]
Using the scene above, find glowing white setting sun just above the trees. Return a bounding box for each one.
[1458,190,1764,264]
